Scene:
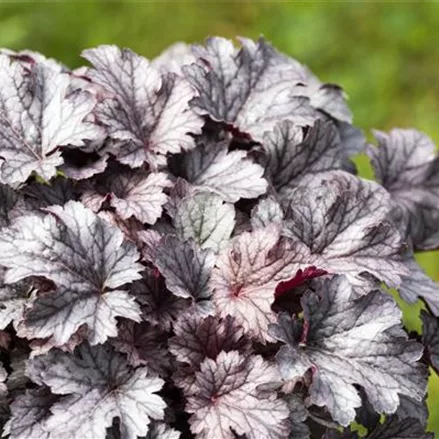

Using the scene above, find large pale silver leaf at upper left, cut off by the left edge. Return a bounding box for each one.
[0,54,102,184]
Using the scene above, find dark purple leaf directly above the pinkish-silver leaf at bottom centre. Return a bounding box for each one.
[169,316,250,369]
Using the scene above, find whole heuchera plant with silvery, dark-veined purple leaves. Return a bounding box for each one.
[0,38,439,439]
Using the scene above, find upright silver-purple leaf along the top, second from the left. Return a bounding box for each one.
[82,45,203,168]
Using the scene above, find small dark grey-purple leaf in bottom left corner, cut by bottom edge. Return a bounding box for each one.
[7,388,58,439]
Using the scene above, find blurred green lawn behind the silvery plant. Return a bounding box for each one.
[0,0,439,437]
